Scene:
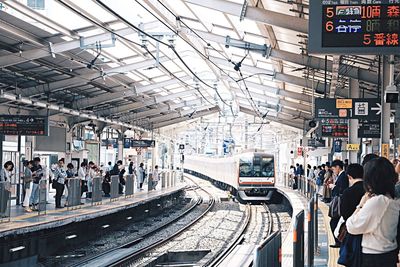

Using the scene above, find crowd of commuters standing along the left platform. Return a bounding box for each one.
[0,157,159,214]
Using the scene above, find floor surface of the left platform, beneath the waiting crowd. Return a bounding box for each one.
[0,183,186,237]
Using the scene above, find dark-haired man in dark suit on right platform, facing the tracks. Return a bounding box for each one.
[329,160,349,248]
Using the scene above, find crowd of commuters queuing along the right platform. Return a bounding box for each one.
[291,154,400,267]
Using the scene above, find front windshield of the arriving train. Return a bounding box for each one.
[239,155,275,177]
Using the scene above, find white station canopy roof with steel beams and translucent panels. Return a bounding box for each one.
[0,0,398,134]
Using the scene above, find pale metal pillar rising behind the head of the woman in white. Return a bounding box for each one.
[380,56,394,154]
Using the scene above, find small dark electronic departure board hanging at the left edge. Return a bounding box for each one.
[0,115,49,136]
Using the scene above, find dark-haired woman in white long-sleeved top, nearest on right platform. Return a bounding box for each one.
[346,157,400,267]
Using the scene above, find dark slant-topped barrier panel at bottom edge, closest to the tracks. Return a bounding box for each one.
[253,231,282,267]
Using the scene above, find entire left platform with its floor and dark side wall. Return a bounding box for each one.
[0,176,186,266]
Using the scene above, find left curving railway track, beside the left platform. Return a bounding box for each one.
[65,178,215,267]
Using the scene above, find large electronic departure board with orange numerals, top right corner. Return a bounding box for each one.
[309,0,400,54]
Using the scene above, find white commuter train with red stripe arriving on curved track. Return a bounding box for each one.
[184,152,276,202]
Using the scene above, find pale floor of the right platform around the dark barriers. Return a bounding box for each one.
[277,186,335,267]
